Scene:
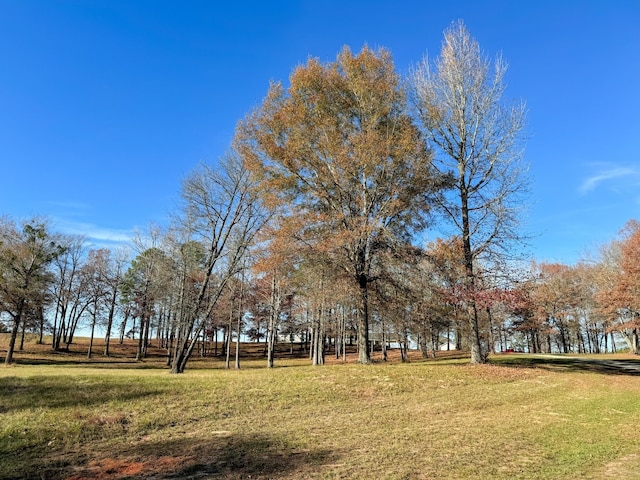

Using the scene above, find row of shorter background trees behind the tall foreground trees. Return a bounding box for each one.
[0,216,640,367]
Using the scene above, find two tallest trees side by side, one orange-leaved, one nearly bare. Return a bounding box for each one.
[235,24,522,363]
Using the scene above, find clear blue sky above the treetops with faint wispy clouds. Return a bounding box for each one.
[0,0,640,263]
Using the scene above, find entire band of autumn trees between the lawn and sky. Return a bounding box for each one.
[0,23,640,373]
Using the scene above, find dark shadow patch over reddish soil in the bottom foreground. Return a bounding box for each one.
[43,432,339,480]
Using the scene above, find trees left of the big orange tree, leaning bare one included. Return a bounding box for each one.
[0,153,268,373]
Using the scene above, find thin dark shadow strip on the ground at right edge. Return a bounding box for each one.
[491,355,640,376]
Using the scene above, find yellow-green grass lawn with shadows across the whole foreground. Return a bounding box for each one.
[0,338,640,480]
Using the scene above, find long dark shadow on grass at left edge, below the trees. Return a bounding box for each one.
[0,375,163,413]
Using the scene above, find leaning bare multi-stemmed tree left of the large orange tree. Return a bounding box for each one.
[171,153,265,373]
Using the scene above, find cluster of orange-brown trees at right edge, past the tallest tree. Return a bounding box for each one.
[509,220,640,354]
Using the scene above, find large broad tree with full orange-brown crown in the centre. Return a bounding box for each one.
[236,47,442,363]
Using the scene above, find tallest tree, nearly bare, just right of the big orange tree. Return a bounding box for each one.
[412,22,526,363]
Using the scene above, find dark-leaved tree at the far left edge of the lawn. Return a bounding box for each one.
[0,220,63,365]
